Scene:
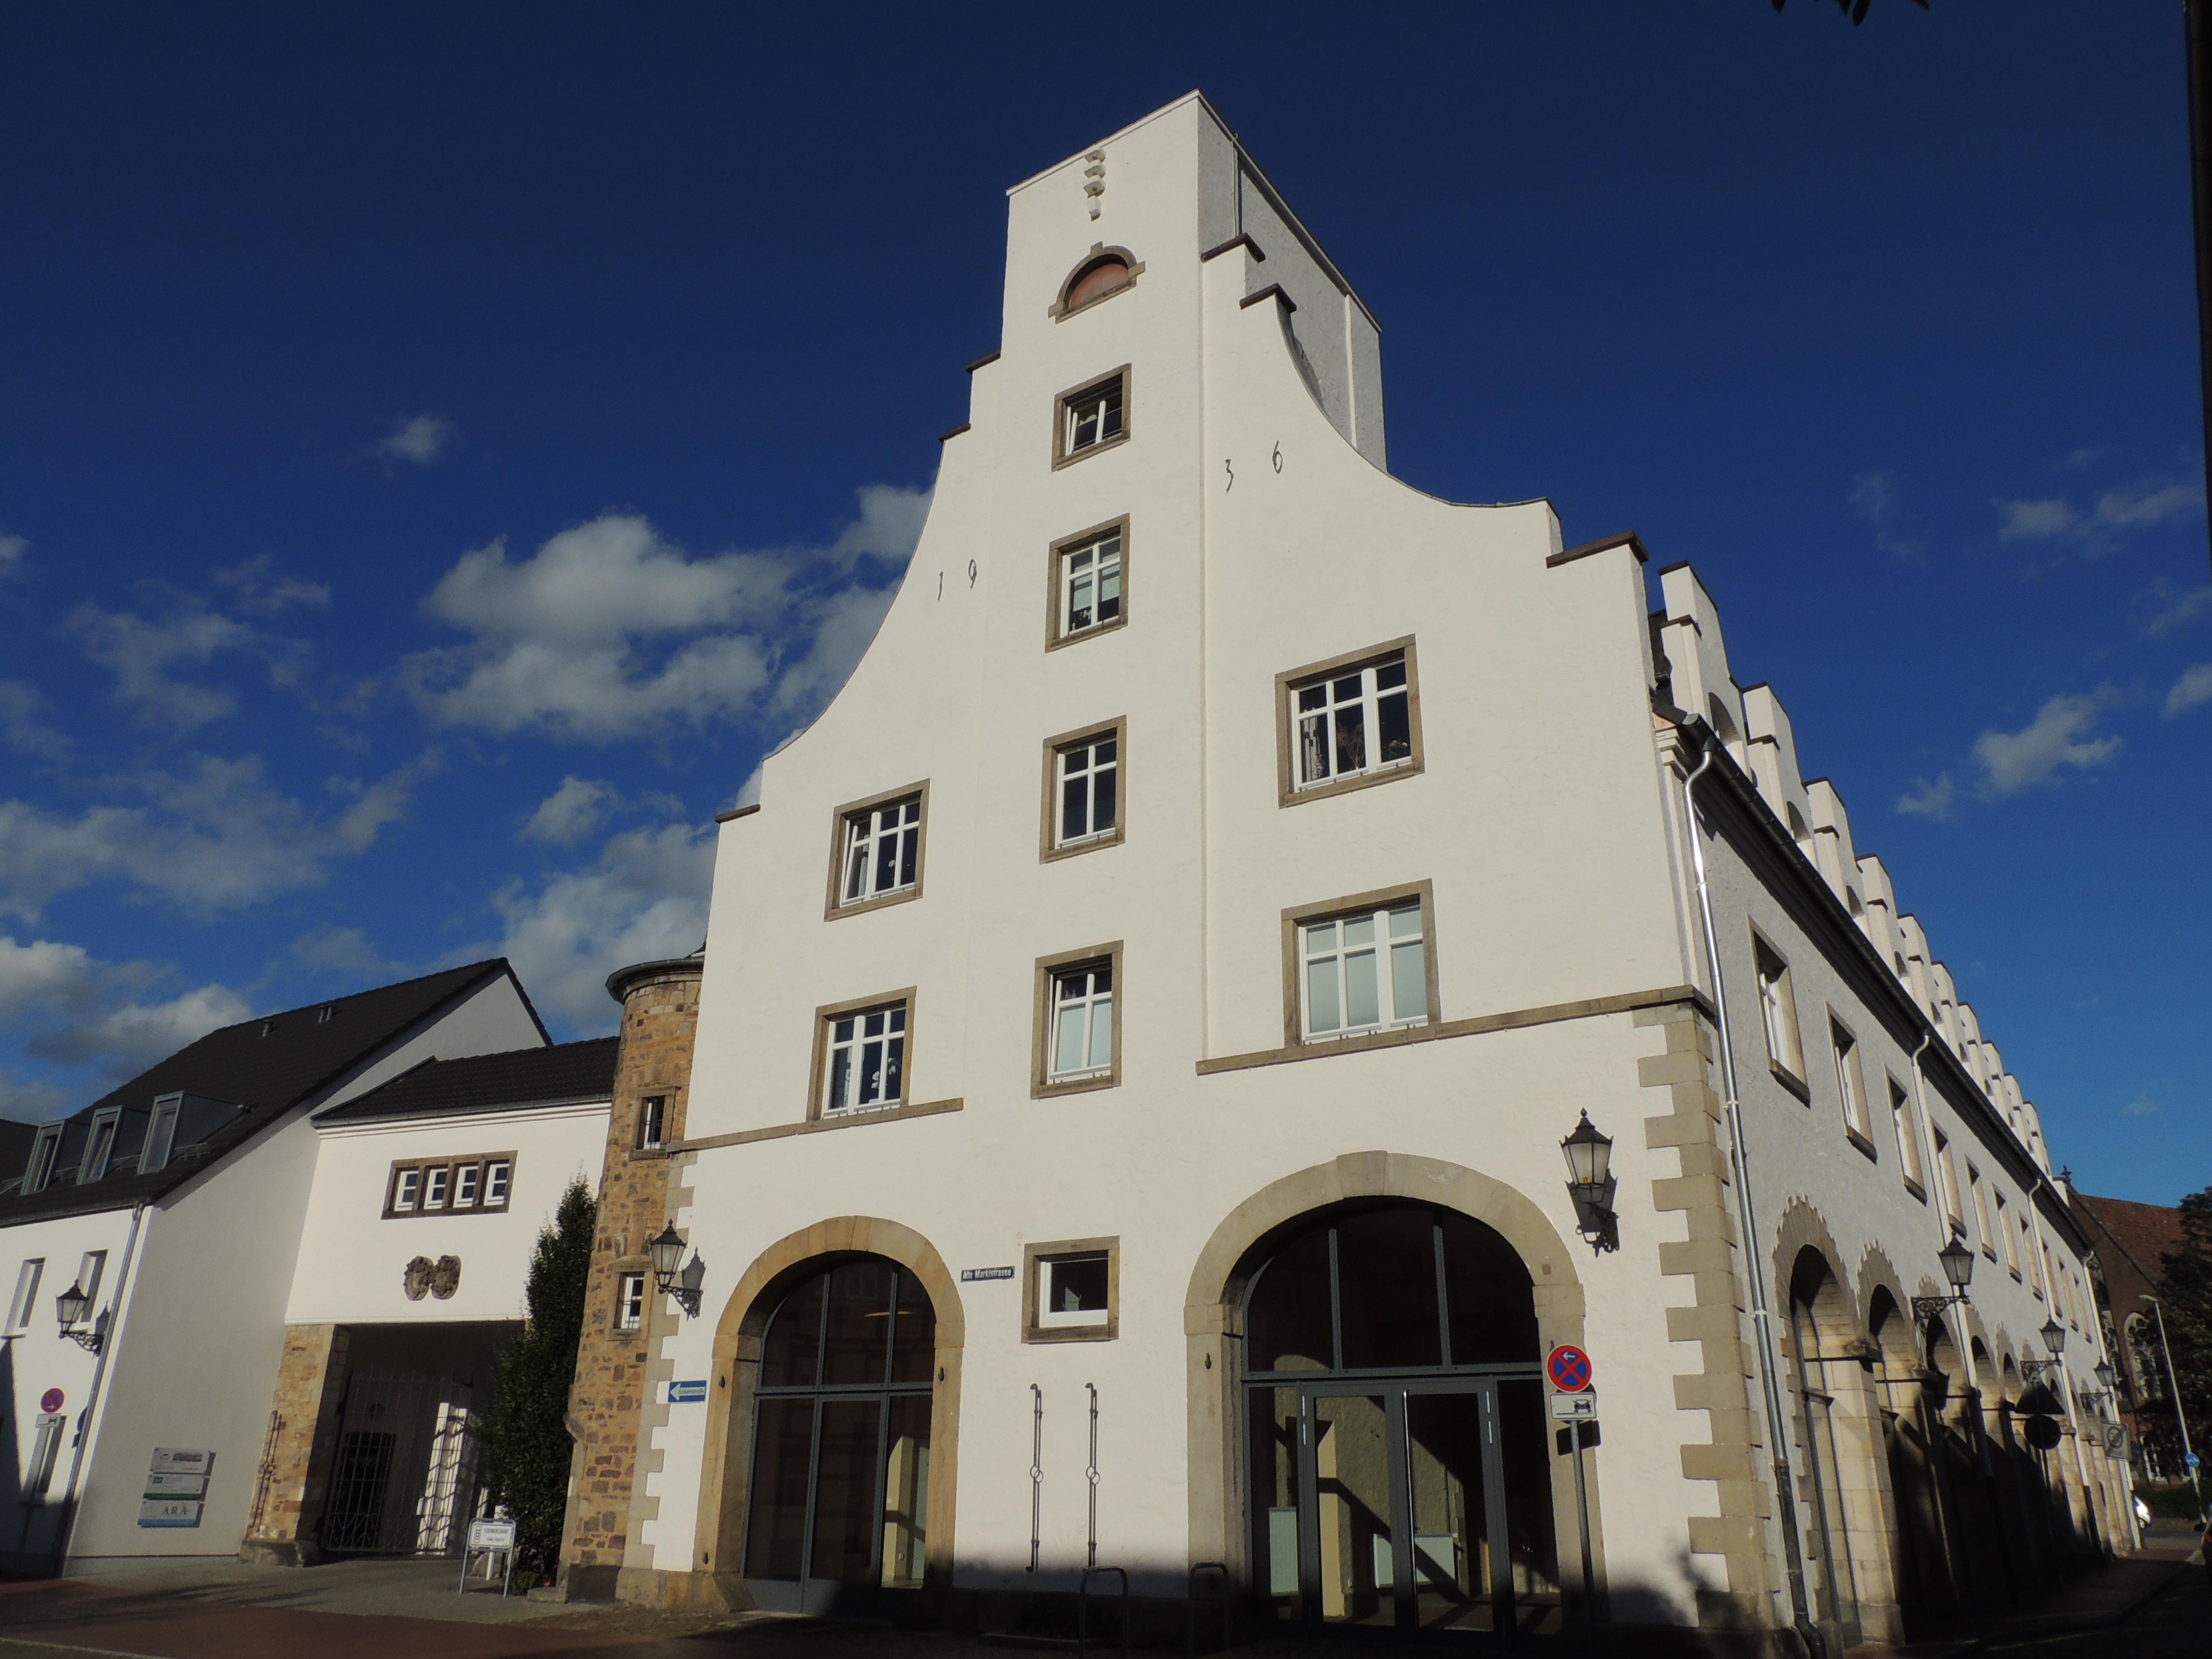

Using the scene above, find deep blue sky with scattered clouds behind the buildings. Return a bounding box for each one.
[0,0,2212,1201]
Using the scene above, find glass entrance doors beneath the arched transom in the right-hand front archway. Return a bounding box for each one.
[1252,1376,1560,1633]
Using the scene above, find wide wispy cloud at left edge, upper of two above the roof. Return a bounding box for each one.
[0,757,436,920]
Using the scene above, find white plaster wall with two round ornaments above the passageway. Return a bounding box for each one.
[285,1102,608,1325]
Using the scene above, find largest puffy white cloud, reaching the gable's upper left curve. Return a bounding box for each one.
[398,484,929,743]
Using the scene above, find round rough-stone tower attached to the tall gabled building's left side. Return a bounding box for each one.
[560,953,706,1601]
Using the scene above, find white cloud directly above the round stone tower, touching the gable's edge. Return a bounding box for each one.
[491,823,714,1031]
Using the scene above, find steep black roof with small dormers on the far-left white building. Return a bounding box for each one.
[0,958,526,1226]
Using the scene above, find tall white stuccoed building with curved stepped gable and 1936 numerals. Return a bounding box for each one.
[590,95,2128,1648]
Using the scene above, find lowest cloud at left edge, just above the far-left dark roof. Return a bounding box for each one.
[0,934,250,1093]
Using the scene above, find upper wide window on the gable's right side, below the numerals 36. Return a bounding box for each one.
[1276,639,1420,805]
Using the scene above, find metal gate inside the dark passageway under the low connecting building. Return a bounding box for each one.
[321,1376,476,1555]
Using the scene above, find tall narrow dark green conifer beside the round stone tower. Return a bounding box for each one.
[482,1181,600,1582]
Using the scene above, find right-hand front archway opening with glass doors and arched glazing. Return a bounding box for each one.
[1241,1203,1562,1633]
